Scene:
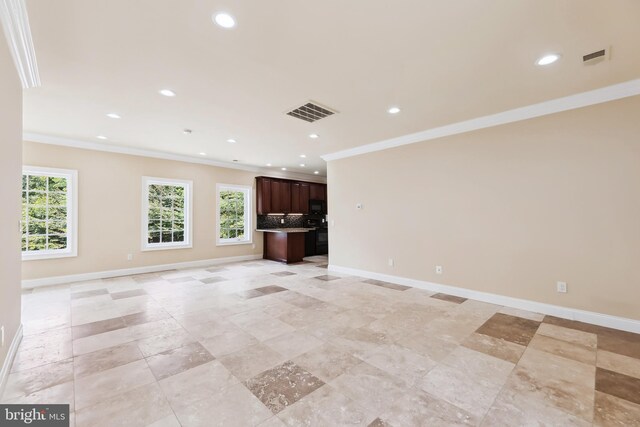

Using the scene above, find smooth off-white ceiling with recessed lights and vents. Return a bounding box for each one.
[24,0,640,175]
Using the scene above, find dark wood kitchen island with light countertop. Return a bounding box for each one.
[256,228,314,264]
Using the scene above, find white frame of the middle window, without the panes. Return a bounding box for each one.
[141,176,193,251]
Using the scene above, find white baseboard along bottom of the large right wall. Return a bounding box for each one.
[328,265,640,333]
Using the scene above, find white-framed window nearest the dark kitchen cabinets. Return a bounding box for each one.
[216,184,253,245]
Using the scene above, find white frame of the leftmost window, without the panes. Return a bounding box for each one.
[20,166,78,261]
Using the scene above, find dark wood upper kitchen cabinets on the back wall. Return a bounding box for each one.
[256,176,327,215]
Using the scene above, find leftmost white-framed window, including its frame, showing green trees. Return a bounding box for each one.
[20,166,78,261]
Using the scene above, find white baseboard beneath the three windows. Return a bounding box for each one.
[22,254,262,289]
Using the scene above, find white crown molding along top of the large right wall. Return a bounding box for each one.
[321,79,640,162]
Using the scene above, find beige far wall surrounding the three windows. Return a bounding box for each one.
[22,142,262,281]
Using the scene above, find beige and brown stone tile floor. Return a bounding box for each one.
[1,257,640,427]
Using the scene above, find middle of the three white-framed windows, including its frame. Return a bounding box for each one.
[142,176,192,250]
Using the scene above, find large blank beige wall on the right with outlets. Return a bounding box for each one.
[328,96,640,319]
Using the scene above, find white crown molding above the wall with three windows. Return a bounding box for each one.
[22,132,327,184]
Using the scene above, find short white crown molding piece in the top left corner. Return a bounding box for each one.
[0,0,40,89]
